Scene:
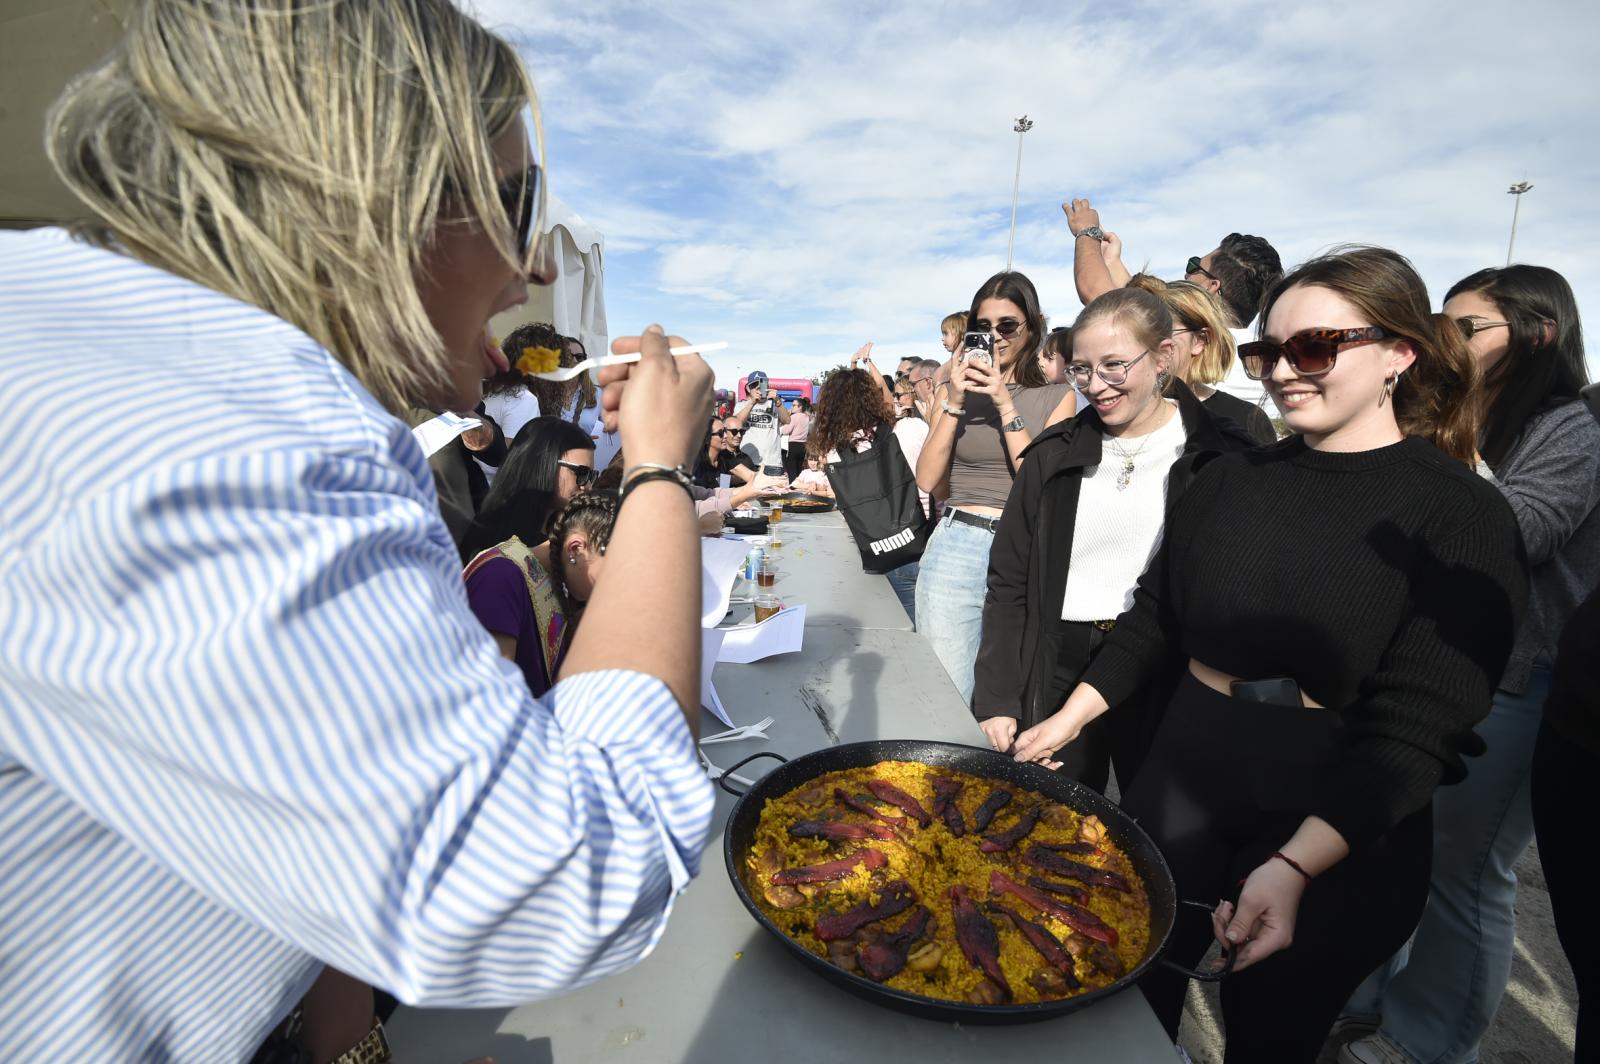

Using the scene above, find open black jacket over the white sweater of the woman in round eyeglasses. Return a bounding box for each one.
[973,381,1256,728]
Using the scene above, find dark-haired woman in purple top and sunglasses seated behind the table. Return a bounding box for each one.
[462,418,595,696]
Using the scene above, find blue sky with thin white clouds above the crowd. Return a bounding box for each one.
[474,0,1600,386]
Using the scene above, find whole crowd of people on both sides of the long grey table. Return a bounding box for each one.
[0,0,1600,1064]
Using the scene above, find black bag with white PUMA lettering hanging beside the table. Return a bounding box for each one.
[827,424,933,573]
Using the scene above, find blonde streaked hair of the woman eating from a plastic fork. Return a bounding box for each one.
[46,0,544,411]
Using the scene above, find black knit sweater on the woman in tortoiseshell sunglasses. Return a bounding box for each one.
[1083,437,1526,850]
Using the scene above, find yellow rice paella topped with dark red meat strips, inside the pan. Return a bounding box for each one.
[744,762,1150,1005]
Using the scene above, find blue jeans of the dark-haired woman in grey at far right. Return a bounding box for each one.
[1344,664,1550,1064]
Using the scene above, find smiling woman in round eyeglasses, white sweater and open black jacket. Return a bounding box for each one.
[973,288,1254,790]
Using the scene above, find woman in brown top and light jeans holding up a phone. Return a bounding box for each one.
[917,272,1077,701]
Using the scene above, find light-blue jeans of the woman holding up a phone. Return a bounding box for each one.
[915,510,995,704]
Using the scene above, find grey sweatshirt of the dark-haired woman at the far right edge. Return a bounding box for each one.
[1490,402,1600,694]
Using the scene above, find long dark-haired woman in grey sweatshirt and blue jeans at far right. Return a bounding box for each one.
[1342,264,1600,1064]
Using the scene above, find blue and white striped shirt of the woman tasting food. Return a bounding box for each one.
[0,230,712,1061]
